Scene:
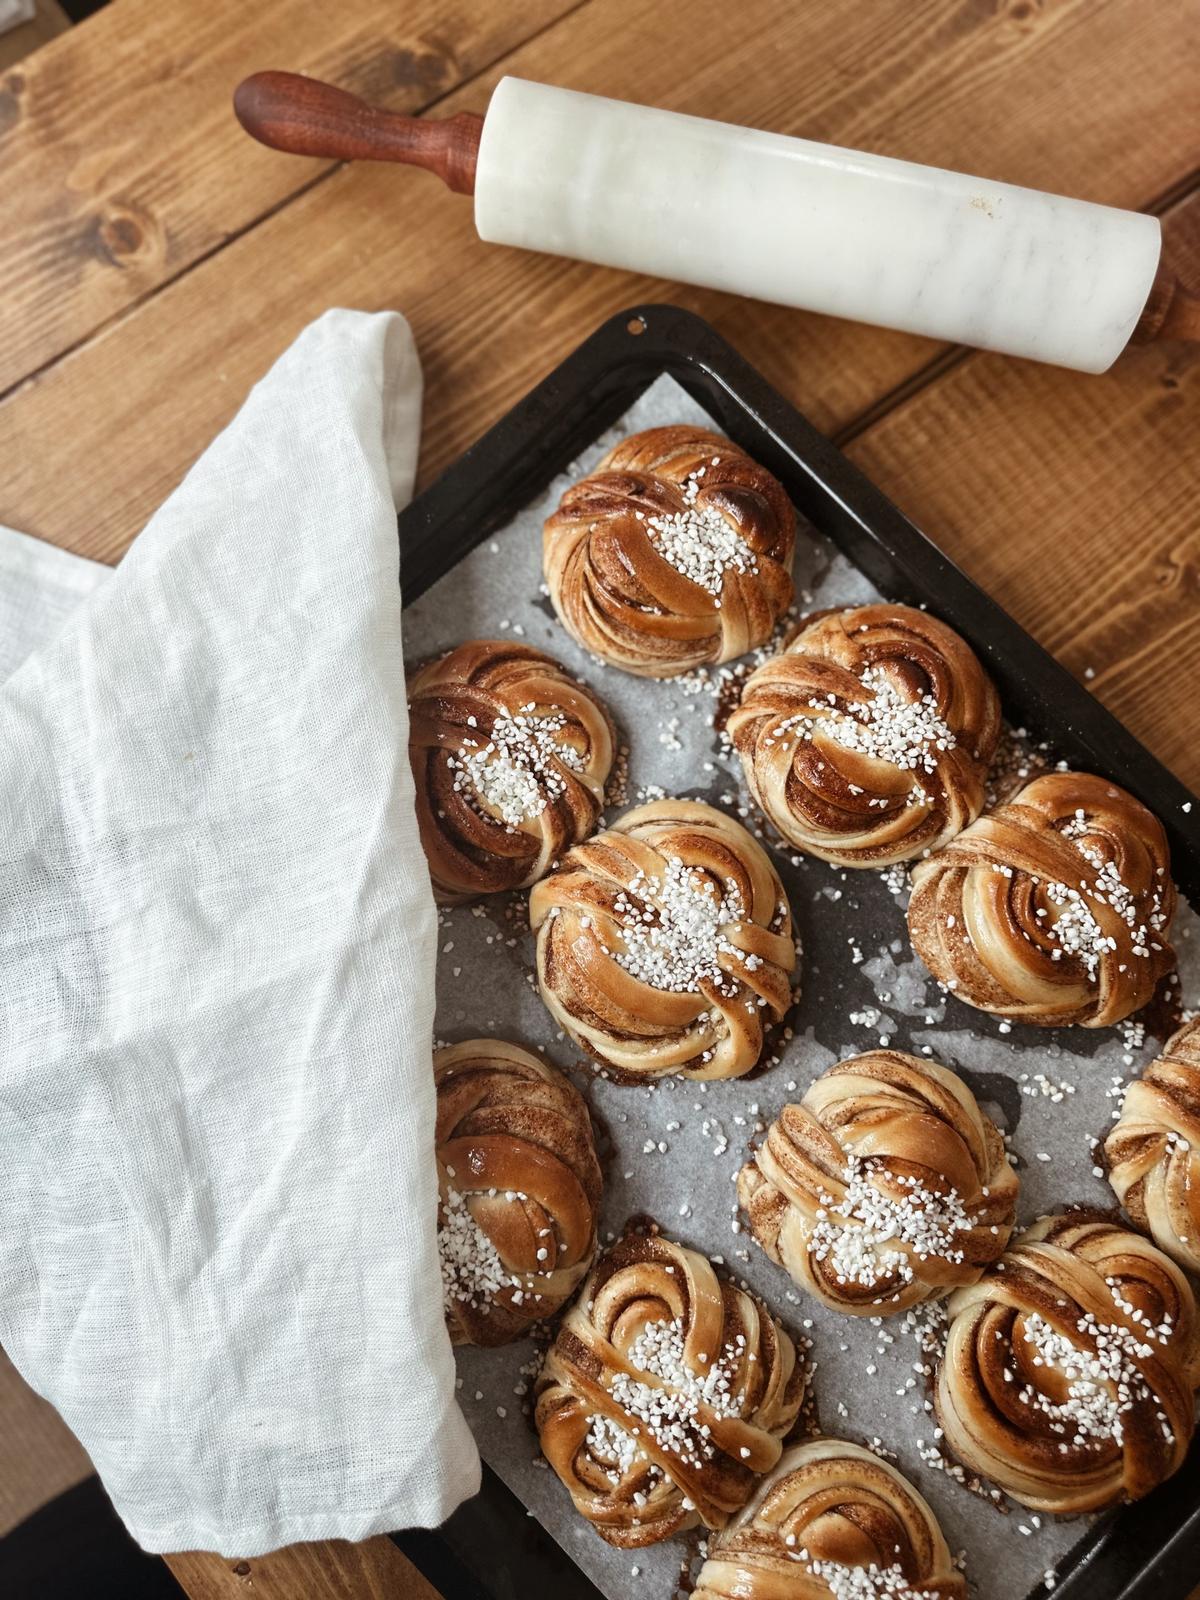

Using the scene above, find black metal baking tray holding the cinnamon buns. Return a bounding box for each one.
[395,306,1200,1600]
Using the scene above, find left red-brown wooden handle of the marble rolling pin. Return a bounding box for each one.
[234,72,483,195]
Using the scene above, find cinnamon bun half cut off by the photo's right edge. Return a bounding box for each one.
[1104,1018,1200,1274]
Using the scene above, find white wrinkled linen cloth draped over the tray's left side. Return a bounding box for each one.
[0,312,478,1555]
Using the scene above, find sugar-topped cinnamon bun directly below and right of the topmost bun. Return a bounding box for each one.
[728,605,1000,867]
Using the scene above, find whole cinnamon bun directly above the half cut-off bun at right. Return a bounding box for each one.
[909,773,1174,1027]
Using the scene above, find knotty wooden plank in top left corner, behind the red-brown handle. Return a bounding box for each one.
[0,0,578,392]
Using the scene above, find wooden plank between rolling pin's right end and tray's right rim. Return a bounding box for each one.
[848,194,1200,790]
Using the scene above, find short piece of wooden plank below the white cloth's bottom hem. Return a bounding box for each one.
[166,1538,440,1600]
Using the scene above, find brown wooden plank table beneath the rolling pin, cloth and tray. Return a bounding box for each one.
[0,0,1200,1600]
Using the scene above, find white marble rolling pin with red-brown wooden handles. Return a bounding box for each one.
[234,72,1200,373]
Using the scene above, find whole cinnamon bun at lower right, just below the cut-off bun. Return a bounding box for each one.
[936,1213,1200,1515]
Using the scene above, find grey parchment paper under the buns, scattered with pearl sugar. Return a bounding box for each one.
[405,376,1200,1600]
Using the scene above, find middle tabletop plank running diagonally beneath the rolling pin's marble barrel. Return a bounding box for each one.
[0,0,1190,560]
